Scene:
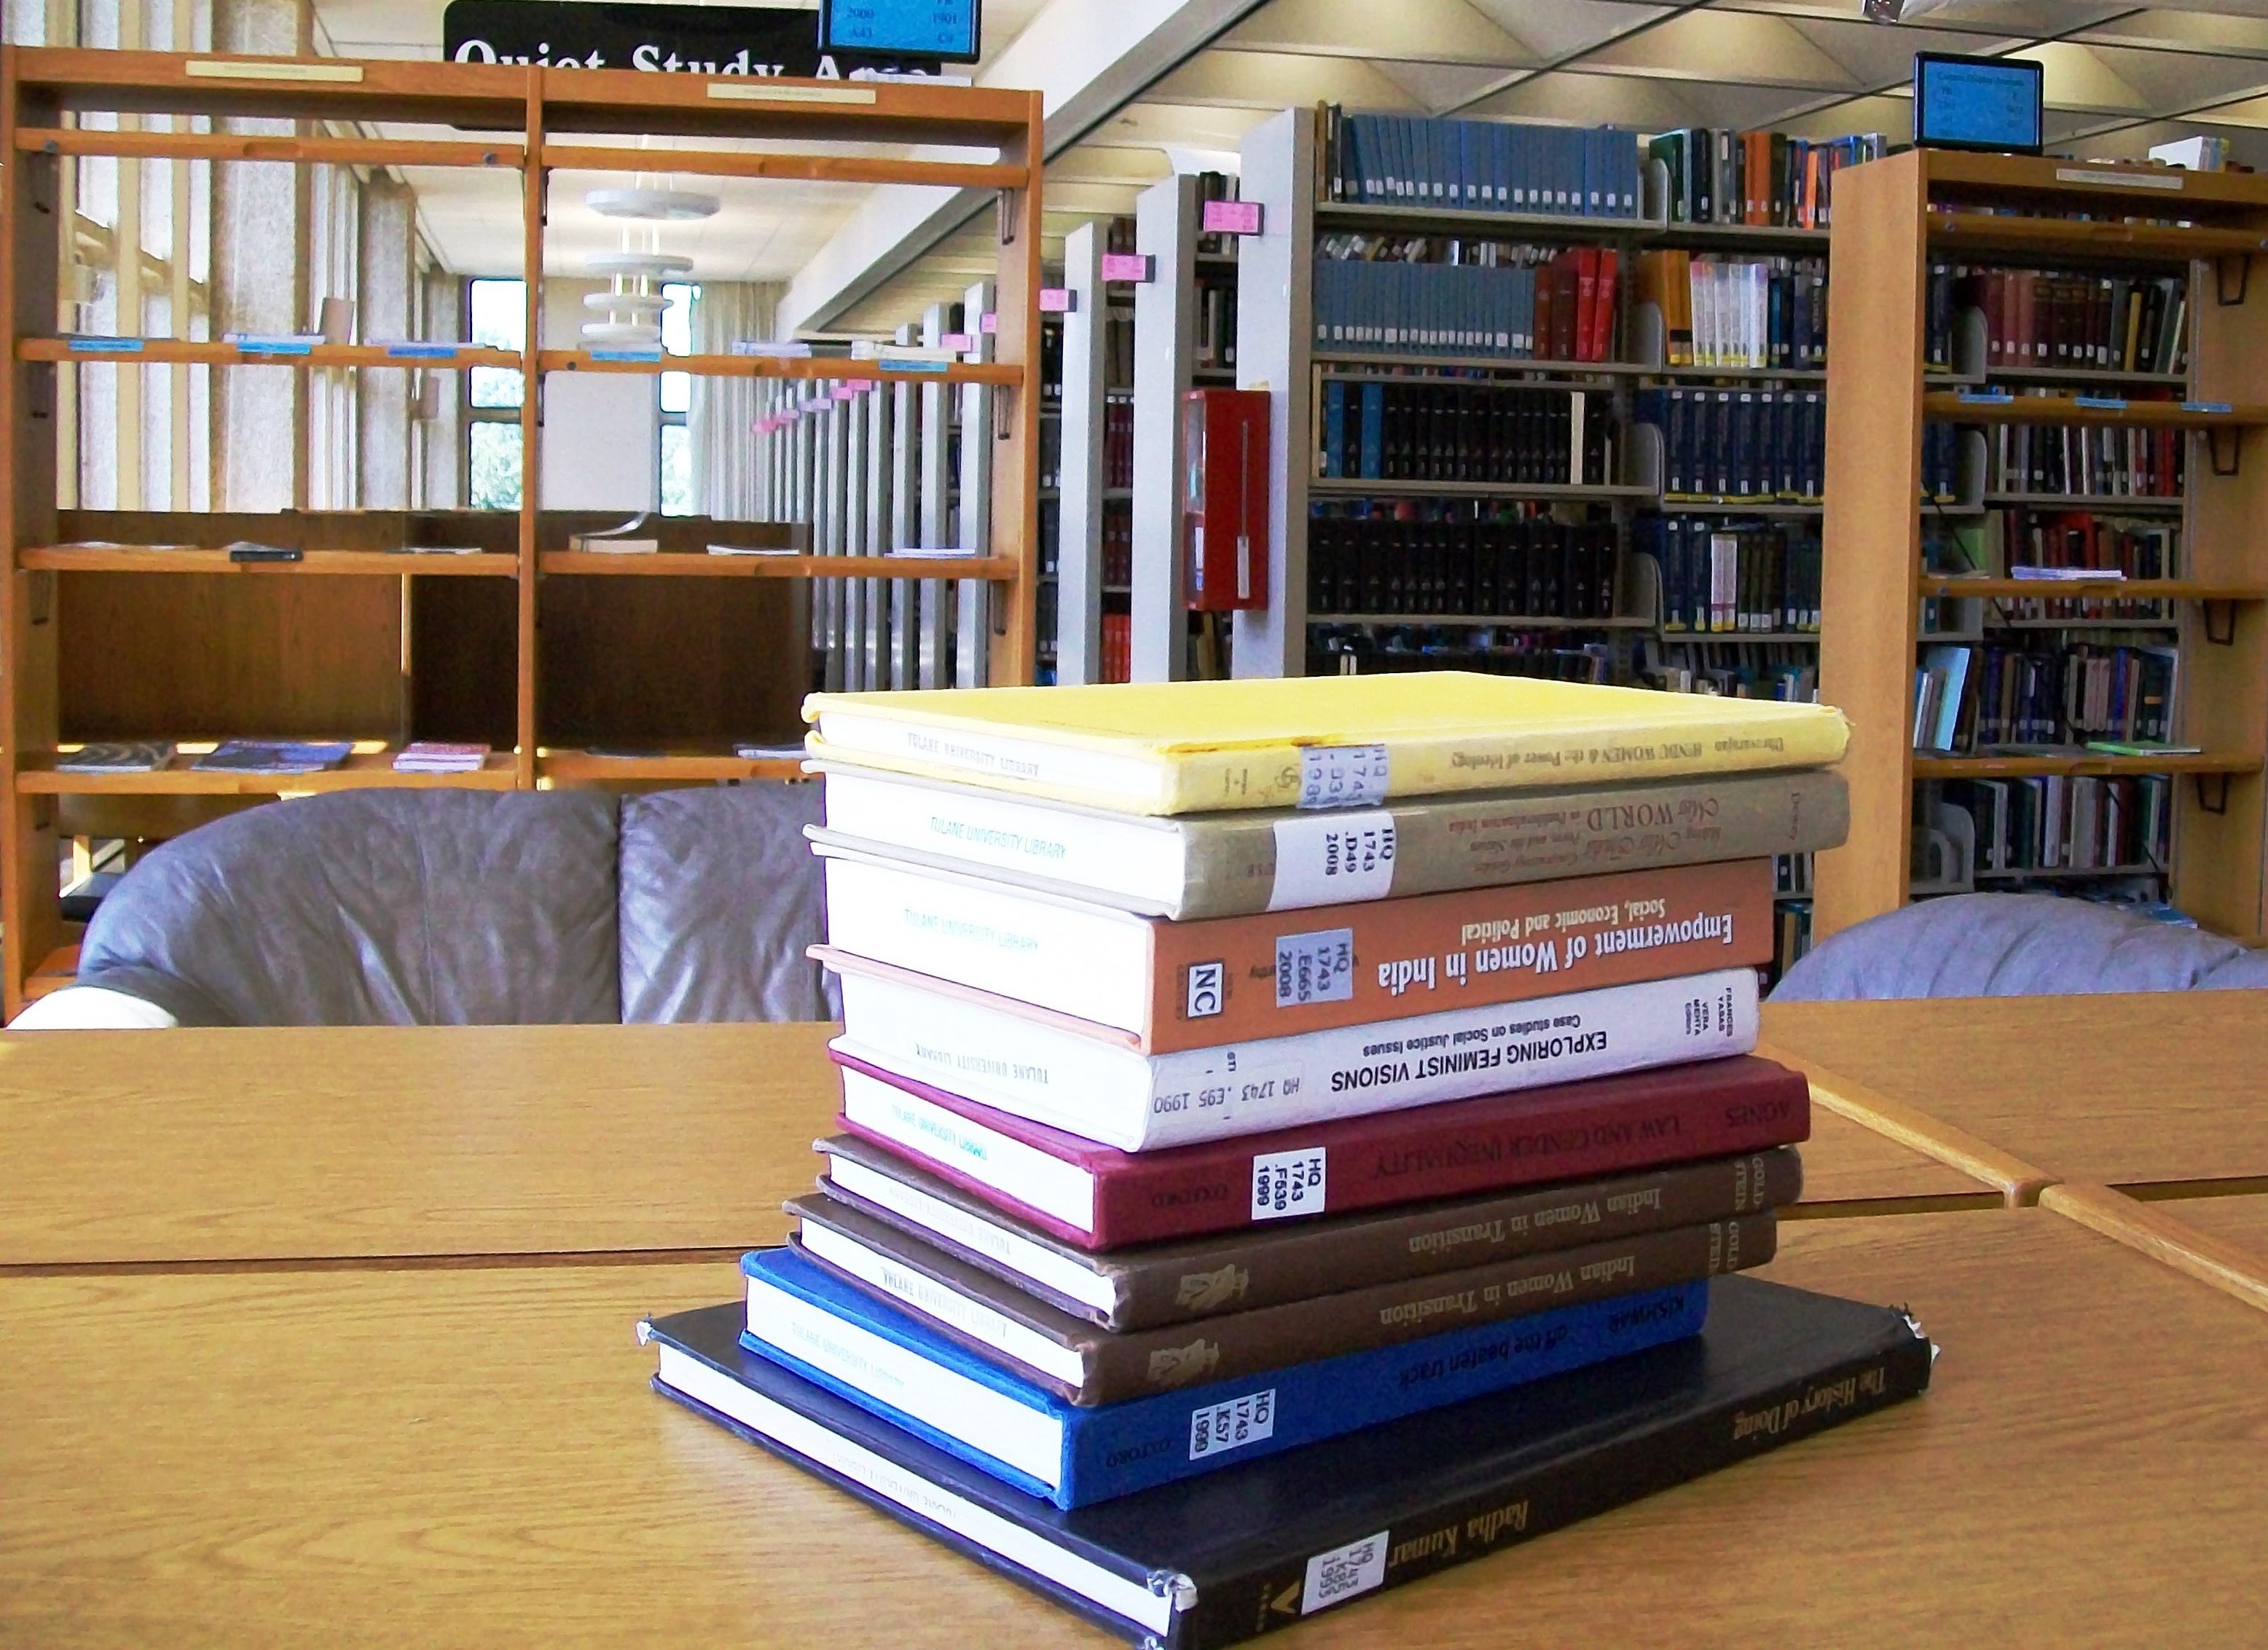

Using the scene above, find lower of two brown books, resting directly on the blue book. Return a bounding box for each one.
[787,1197,1778,1407]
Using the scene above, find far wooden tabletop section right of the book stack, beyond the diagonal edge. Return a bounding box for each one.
[1765,991,2268,1197]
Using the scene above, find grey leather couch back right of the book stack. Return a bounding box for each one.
[1771,893,2268,1002]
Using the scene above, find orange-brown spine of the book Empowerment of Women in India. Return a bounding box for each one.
[1152,859,1773,1054]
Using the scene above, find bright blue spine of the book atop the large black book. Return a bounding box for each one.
[1055,1283,1708,1507]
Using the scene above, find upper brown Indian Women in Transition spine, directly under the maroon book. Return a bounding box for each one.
[1109,1147,1803,1330]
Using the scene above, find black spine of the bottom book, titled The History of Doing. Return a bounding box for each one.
[1170,1332,1930,1650]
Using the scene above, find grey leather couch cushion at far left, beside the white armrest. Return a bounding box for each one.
[79,791,619,1024]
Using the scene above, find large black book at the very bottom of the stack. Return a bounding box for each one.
[651,1278,1934,1650]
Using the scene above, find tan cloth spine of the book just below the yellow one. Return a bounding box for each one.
[1175,771,1851,920]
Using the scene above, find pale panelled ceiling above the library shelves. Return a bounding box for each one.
[302,0,2268,331]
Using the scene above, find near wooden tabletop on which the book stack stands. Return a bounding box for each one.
[13,1210,2268,1650]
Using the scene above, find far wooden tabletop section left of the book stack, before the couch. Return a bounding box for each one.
[0,1024,839,1265]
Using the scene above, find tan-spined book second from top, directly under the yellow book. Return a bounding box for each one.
[805,761,1848,920]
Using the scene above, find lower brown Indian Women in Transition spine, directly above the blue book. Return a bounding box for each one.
[1079,1215,1778,1405]
